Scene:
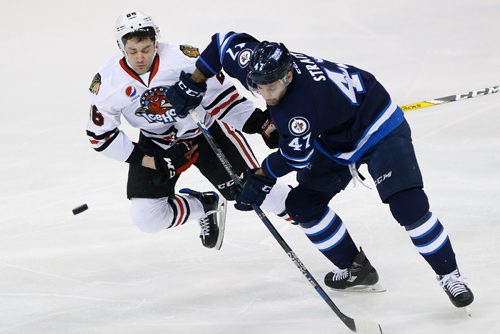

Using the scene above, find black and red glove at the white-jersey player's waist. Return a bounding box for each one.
[154,141,200,183]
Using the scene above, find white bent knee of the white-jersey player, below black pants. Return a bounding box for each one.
[130,198,171,233]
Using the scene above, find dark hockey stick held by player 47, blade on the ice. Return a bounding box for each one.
[189,109,382,334]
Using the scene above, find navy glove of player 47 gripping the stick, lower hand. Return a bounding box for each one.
[234,169,276,211]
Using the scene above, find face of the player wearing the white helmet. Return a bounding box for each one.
[125,38,155,74]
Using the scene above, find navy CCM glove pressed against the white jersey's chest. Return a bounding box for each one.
[165,71,207,118]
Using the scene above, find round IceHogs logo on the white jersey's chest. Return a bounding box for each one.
[135,86,177,124]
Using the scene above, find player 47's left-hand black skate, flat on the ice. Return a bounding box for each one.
[325,248,385,292]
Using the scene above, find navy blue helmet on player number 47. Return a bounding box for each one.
[248,41,292,85]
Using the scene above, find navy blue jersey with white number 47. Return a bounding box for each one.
[196,32,404,178]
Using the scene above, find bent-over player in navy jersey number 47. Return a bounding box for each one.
[167,32,474,307]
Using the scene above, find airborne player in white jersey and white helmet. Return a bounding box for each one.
[87,11,289,249]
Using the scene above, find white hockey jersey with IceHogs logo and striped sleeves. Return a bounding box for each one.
[87,43,254,161]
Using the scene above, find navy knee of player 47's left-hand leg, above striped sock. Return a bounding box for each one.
[285,185,333,224]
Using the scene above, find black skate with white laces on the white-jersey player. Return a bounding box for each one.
[179,188,227,250]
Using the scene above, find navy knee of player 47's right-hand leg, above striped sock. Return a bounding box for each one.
[387,188,429,226]
